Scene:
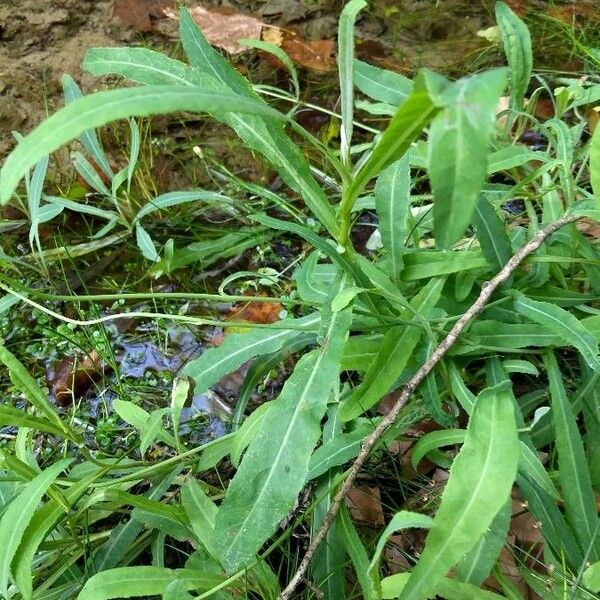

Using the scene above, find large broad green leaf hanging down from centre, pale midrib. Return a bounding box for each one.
[215,277,351,572]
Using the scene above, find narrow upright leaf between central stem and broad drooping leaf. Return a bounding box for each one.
[375,154,410,281]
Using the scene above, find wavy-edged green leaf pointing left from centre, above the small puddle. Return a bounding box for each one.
[181,314,320,394]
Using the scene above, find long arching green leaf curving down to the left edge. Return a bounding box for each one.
[0,85,282,204]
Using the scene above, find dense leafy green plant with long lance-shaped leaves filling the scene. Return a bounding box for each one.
[0,0,600,600]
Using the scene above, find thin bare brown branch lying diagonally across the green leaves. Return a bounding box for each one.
[278,216,580,600]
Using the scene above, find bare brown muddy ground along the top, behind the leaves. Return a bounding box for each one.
[0,0,600,159]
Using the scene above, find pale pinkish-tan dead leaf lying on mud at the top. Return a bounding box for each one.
[164,6,264,54]
